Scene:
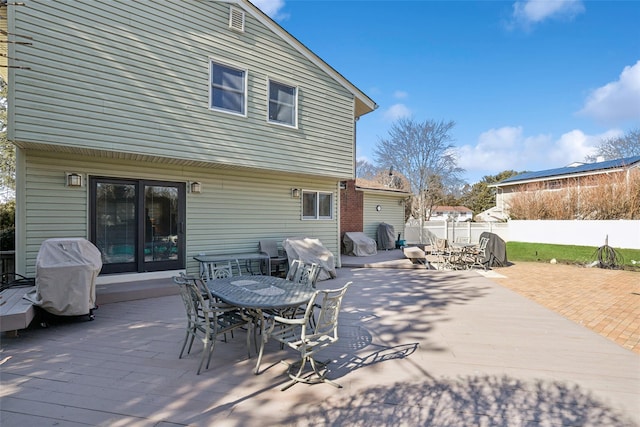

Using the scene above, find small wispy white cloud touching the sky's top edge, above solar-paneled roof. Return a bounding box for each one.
[512,0,584,27]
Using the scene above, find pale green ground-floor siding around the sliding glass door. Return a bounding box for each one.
[18,150,339,276]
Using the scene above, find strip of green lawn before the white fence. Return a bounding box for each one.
[507,242,640,271]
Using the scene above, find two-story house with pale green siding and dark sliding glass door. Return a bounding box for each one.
[0,0,376,283]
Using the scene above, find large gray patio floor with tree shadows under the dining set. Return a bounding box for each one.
[0,253,640,427]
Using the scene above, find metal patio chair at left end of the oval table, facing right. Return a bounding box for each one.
[173,276,253,375]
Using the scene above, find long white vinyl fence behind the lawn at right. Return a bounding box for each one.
[404,219,640,249]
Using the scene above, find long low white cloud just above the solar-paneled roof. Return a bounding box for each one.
[458,126,622,183]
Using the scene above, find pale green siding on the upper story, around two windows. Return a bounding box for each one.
[9,0,355,179]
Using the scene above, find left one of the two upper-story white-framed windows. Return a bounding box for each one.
[209,61,247,115]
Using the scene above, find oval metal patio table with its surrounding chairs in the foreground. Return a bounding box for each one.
[173,241,351,390]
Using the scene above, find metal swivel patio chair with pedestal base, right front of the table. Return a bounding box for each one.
[256,282,352,390]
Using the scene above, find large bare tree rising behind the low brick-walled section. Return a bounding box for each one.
[374,118,464,240]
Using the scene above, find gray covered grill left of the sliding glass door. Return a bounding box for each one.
[27,238,102,316]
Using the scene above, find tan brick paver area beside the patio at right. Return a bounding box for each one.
[490,262,640,354]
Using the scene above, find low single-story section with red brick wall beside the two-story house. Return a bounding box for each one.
[340,178,411,249]
